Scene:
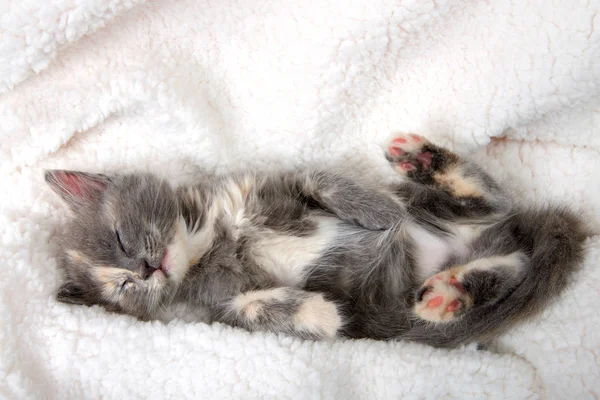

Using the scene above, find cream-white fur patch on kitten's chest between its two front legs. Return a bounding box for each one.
[252,216,342,287]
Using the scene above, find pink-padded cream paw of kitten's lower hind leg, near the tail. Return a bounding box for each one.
[414,269,473,322]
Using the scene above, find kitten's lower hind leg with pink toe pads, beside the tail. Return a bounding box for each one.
[414,252,528,322]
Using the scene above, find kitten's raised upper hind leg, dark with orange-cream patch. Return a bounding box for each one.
[386,134,511,218]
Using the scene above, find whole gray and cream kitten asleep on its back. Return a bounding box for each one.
[46,135,586,346]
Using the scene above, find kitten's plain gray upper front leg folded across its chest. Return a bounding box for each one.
[290,172,406,230]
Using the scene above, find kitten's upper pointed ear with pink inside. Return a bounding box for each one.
[44,169,110,211]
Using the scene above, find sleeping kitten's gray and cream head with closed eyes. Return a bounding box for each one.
[45,170,188,318]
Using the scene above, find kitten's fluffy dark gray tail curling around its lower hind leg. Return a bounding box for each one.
[401,207,591,347]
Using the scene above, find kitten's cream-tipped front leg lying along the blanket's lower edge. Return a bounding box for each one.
[217,287,343,340]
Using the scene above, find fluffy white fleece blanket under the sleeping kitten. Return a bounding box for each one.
[0,0,600,399]
